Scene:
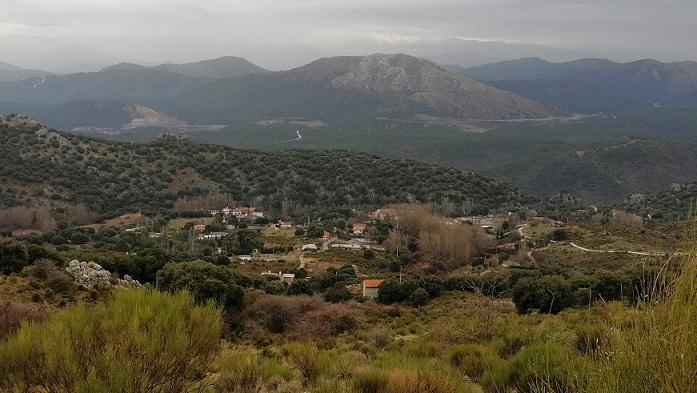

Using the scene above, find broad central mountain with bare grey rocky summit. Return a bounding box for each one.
[167,54,563,123]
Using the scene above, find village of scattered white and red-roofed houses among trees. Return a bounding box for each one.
[102,202,608,299]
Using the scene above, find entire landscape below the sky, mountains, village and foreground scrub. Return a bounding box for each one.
[0,45,697,393]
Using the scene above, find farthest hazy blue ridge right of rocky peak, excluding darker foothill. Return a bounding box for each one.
[464,58,697,103]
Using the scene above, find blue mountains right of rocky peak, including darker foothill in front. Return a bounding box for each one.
[459,58,697,111]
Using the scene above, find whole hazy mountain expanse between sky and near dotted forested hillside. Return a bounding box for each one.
[0,54,697,203]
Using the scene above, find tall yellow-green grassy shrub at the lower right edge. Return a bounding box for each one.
[591,251,697,393]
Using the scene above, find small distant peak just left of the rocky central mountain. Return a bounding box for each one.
[152,56,270,79]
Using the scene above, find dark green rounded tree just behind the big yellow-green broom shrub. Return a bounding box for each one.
[157,261,244,309]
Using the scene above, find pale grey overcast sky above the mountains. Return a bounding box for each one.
[0,0,697,70]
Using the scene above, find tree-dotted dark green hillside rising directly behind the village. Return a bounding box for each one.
[0,116,526,227]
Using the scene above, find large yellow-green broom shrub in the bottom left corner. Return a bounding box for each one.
[0,289,221,393]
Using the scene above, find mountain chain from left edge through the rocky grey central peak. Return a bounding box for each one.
[0,54,568,126]
